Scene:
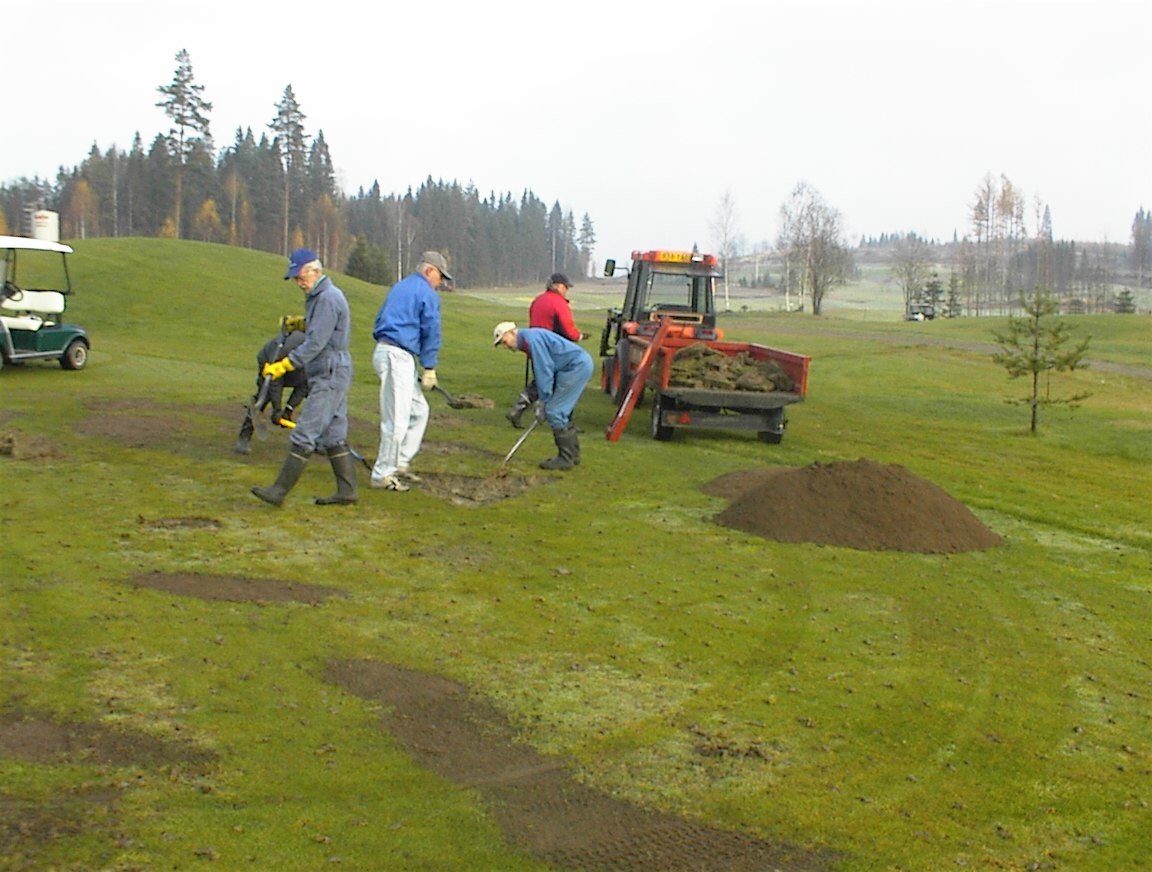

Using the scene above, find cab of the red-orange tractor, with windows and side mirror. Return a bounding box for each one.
[600,250,723,357]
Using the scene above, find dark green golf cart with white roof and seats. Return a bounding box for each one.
[0,236,89,370]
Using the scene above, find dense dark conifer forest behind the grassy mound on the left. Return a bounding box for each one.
[0,51,596,286]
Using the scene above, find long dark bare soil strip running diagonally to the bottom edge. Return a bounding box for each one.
[327,660,834,872]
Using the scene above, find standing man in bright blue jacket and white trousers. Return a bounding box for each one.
[371,251,452,493]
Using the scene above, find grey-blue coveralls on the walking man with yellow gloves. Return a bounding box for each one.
[288,275,353,456]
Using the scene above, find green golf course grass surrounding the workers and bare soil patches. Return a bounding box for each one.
[0,234,1152,872]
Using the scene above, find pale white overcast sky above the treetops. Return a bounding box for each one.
[0,0,1152,261]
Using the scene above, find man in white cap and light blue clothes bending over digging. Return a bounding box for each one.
[492,321,592,469]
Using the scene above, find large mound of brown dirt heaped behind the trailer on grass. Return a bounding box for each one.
[705,460,1003,554]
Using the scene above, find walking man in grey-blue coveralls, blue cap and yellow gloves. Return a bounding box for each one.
[252,249,357,506]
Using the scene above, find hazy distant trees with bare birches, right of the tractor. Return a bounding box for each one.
[721,175,1152,317]
